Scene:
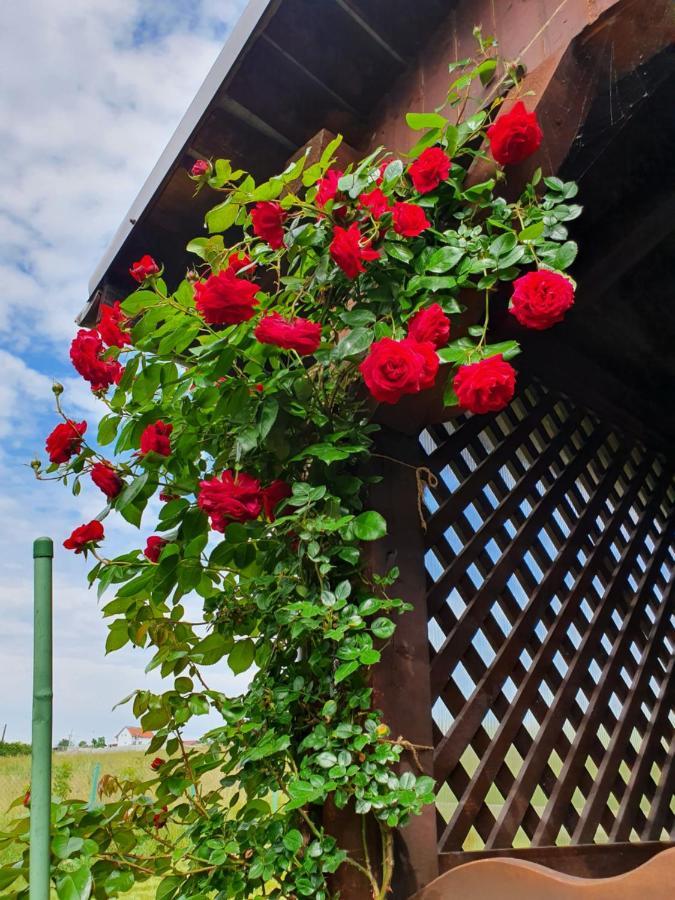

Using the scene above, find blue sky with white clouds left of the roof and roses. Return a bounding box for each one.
[0,0,245,740]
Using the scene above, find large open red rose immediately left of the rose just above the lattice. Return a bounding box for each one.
[359,338,438,403]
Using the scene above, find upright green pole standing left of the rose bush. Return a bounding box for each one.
[29,538,54,900]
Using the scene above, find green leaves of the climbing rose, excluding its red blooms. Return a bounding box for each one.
[5,32,579,900]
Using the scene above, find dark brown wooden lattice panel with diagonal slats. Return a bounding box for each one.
[420,384,675,851]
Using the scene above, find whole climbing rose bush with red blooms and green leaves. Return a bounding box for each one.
[2,43,580,900]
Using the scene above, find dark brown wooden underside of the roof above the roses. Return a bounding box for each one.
[81,0,675,447]
